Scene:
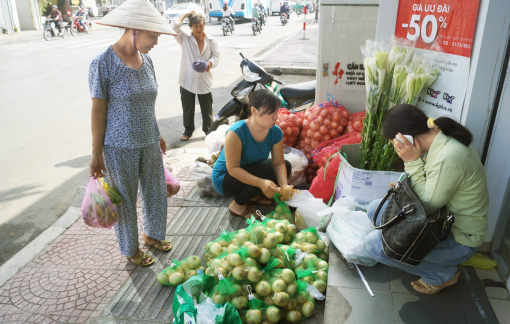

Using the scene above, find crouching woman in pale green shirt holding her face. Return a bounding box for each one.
[365,104,489,294]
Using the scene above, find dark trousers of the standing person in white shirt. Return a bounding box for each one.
[181,87,213,136]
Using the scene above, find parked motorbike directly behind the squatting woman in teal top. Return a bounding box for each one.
[207,53,316,134]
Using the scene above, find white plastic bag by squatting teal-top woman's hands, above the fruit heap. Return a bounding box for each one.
[286,190,331,232]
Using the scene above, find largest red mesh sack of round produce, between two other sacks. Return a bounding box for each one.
[296,101,349,160]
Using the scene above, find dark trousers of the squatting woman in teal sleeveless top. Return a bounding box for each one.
[223,159,292,206]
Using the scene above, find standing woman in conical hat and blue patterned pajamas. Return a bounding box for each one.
[89,0,179,266]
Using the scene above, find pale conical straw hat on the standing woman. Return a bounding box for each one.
[97,0,176,35]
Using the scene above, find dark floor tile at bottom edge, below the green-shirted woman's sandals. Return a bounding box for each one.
[392,293,466,324]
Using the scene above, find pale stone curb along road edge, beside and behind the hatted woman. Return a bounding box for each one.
[0,148,192,288]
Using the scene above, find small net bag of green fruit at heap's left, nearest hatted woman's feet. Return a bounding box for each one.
[156,255,205,286]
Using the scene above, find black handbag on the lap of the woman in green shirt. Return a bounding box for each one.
[372,174,455,266]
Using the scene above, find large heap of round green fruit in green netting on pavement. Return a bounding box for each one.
[167,203,328,324]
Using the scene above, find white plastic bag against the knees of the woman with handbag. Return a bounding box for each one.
[318,200,377,266]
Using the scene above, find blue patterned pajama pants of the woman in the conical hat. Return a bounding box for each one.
[103,142,167,256]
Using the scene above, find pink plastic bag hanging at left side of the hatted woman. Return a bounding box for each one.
[81,177,119,228]
